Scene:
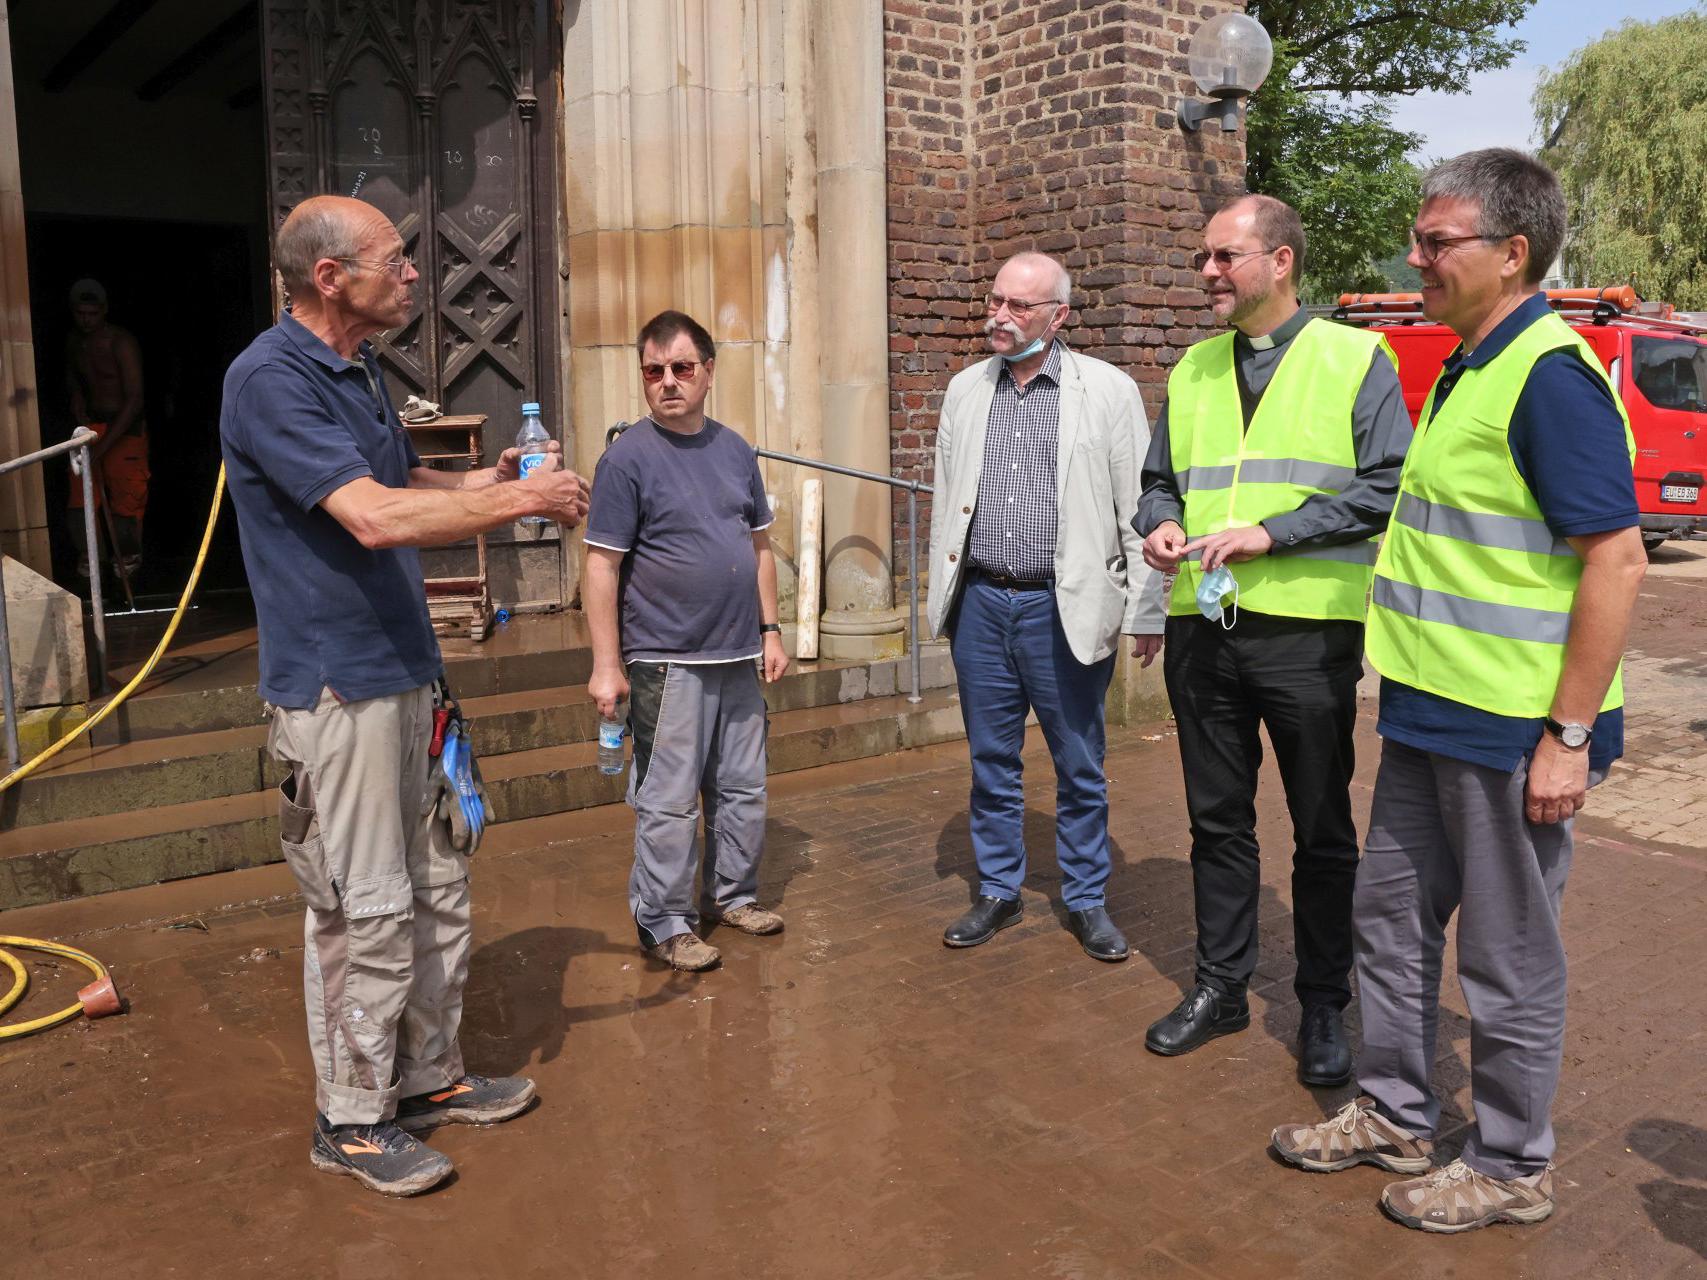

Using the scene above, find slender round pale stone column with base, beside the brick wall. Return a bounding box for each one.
[813,0,903,659]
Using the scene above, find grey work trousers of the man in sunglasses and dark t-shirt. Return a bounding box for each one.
[628,659,768,945]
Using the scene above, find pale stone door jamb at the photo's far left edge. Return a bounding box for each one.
[0,0,53,573]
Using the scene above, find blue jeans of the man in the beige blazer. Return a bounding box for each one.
[951,573,1115,911]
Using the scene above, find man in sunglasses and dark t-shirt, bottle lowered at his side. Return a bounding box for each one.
[582,311,789,971]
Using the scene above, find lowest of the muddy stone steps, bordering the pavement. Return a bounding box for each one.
[0,689,963,910]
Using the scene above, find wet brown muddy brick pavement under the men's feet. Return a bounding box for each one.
[10,544,1707,1280]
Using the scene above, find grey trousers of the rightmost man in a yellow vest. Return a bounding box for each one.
[1352,739,1605,1178]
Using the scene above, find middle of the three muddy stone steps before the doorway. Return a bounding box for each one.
[0,650,954,831]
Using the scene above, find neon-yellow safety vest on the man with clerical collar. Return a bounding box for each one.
[1168,319,1396,620]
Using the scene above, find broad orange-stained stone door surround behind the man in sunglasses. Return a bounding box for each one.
[562,0,798,616]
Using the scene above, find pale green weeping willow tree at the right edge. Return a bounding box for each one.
[1535,9,1707,311]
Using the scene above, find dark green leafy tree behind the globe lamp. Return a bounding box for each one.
[1246,0,1535,300]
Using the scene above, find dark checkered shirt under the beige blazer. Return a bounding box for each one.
[968,343,1062,582]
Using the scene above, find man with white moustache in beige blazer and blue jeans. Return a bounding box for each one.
[929,253,1164,961]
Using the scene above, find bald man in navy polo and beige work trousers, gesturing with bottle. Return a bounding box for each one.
[220,196,587,1195]
